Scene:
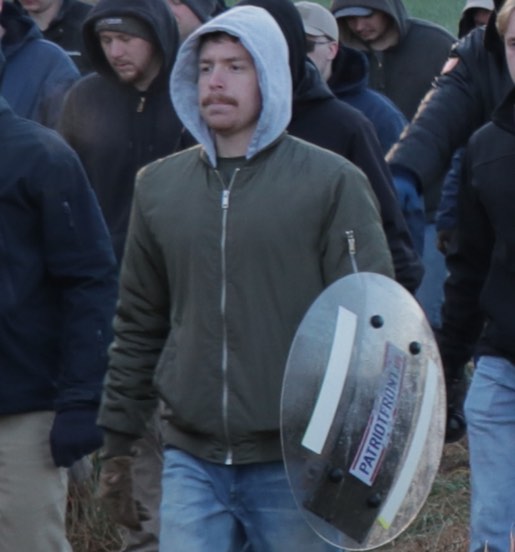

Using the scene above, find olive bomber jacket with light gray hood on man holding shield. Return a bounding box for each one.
[100,6,393,464]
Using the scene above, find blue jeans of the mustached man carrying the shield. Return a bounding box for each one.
[159,448,337,552]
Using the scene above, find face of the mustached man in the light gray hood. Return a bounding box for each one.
[198,37,261,140]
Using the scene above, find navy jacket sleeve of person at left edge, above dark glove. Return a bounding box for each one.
[39,137,117,410]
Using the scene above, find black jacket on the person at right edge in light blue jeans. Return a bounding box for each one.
[438,90,515,376]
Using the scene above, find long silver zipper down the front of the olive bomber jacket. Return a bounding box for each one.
[215,169,239,465]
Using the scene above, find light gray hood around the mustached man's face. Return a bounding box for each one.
[170,6,292,166]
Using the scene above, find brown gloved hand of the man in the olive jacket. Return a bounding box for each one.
[98,456,150,531]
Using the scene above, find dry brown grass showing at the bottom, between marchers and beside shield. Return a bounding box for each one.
[68,440,472,552]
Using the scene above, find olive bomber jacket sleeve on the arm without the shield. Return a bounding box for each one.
[99,175,169,436]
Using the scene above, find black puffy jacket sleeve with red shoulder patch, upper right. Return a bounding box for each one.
[387,0,513,197]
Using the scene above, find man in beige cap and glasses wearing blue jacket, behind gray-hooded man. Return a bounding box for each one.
[295,1,408,154]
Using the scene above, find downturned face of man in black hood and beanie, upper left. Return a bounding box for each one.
[99,31,161,90]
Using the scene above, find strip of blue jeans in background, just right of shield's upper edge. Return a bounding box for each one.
[415,224,447,329]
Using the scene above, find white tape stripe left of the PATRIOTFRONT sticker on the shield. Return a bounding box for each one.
[302,307,357,454]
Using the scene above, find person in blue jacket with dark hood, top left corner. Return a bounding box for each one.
[0,0,80,128]
